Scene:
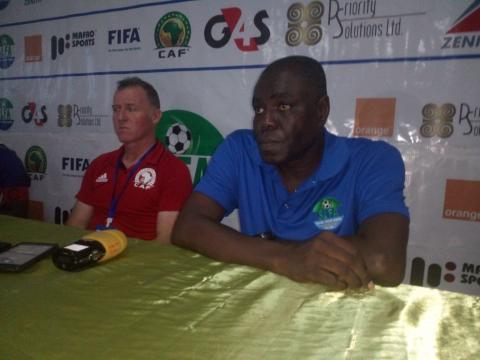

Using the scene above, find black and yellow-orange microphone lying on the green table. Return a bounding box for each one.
[52,229,127,271]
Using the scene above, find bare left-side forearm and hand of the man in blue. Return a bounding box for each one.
[172,192,370,289]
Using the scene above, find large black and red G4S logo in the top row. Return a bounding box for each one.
[204,7,270,51]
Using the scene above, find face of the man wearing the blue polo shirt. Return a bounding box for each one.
[252,70,330,188]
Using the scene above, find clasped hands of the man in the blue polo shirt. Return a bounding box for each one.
[275,232,371,290]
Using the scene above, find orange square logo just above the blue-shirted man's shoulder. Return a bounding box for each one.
[353,98,396,137]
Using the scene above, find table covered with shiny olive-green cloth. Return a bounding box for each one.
[0,216,480,360]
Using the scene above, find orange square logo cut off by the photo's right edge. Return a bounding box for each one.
[443,179,480,222]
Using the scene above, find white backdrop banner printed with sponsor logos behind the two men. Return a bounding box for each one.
[0,0,480,294]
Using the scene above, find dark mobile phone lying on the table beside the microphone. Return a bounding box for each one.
[0,242,58,272]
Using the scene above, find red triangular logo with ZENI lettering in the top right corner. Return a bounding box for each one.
[441,0,480,49]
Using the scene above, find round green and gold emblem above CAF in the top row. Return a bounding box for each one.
[155,11,192,49]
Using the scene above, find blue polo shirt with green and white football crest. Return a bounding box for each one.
[195,130,409,241]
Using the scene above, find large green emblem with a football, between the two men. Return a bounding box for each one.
[156,110,223,185]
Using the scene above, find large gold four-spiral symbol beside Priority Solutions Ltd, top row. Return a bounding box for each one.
[285,1,324,46]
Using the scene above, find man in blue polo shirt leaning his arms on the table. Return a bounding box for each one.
[173,56,409,289]
